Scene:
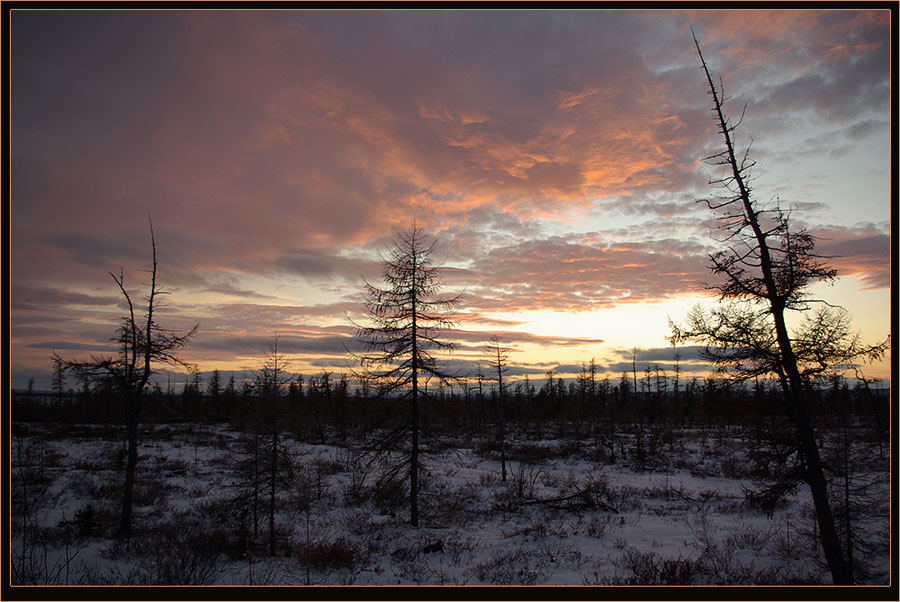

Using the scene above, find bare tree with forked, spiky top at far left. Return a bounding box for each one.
[52,221,197,537]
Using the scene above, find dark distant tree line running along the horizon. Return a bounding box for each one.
[12,365,890,443]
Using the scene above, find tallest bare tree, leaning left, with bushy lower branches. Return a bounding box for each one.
[671,32,888,584]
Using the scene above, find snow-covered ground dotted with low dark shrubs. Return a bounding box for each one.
[10,424,890,586]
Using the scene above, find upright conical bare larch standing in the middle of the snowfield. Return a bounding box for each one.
[355,222,459,527]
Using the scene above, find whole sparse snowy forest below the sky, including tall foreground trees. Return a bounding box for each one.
[7,36,893,586]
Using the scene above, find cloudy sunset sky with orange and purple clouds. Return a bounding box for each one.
[6,9,893,388]
